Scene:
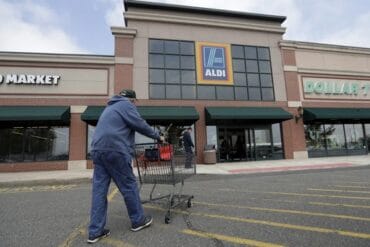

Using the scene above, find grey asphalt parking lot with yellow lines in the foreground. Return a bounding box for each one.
[0,167,370,247]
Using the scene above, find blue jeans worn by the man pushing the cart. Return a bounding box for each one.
[89,151,144,236]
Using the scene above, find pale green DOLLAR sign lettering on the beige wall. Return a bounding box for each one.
[302,77,370,100]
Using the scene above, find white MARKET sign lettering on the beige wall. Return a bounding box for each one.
[0,74,60,85]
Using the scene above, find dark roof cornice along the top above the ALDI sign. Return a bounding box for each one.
[124,0,286,23]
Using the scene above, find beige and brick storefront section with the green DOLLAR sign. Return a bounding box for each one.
[280,41,370,157]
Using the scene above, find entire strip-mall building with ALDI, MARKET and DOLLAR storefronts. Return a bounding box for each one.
[0,0,370,172]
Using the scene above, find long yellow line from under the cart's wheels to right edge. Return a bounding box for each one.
[145,205,370,239]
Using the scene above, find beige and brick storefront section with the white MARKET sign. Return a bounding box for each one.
[0,52,115,172]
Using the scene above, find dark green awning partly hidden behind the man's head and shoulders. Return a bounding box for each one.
[81,106,199,125]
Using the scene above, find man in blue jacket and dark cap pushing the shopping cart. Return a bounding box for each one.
[87,90,163,243]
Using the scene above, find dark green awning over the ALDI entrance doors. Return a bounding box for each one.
[206,107,293,124]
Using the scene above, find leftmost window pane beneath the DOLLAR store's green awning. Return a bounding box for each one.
[304,124,325,151]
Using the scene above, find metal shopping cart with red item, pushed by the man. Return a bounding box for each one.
[135,143,196,224]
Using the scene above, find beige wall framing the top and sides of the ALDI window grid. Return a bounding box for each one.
[129,20,286,101]
